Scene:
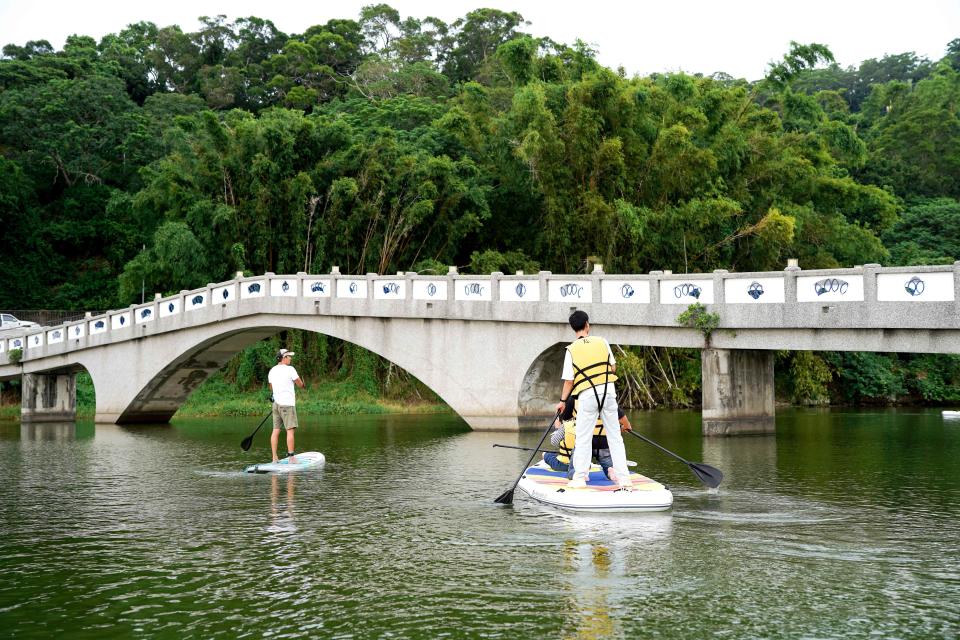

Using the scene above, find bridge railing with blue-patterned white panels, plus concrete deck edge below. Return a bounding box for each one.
[0,262,960,364]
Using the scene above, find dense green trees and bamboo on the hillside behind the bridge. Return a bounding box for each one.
[0,4,960,412]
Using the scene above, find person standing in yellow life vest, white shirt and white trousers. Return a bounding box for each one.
[556,310,633,491]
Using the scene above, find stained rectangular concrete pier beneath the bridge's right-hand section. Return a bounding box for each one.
[700,349,775,436]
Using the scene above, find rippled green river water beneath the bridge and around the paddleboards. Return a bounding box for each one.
[0,410,960,639]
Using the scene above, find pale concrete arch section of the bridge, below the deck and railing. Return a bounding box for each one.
[72,314,563,430]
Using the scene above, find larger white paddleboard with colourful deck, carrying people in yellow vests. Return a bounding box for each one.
[517,462,673,512]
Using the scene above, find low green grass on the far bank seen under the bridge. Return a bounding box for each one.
[0,373,450,420]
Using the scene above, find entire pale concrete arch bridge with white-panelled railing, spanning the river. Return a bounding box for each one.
[0,262,960,434]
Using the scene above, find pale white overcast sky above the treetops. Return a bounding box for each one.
[0,0,960,80]
